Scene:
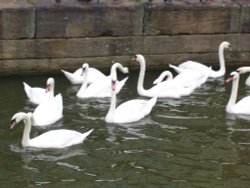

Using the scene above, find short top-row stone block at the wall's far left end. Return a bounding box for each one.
[0,8,35,39]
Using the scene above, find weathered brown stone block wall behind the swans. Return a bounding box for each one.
[0,3,250,75]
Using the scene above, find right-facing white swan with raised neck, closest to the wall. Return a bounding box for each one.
[171,41,231,78]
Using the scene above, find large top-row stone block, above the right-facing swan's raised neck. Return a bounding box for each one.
[144,6,230,35]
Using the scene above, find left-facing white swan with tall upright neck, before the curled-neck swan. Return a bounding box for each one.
[132,54,193,98]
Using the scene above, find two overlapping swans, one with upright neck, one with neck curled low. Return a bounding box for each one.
[132,54,207,98]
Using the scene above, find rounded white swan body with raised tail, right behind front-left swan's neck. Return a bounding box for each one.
[33,94,63,126]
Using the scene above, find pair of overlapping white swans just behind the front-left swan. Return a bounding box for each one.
[24,78,63,126]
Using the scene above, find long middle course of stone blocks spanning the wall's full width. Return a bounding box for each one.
[0,34,250,59]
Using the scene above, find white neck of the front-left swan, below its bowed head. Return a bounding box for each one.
[22,114,32,146]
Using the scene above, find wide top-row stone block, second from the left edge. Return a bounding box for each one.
[36,6,143,38]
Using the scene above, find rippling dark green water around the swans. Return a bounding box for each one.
[0,71,250,188]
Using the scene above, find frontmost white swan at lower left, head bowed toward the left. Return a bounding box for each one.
[10,112,93,148]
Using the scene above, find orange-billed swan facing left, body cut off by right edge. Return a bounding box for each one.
[226,72,250,115]
